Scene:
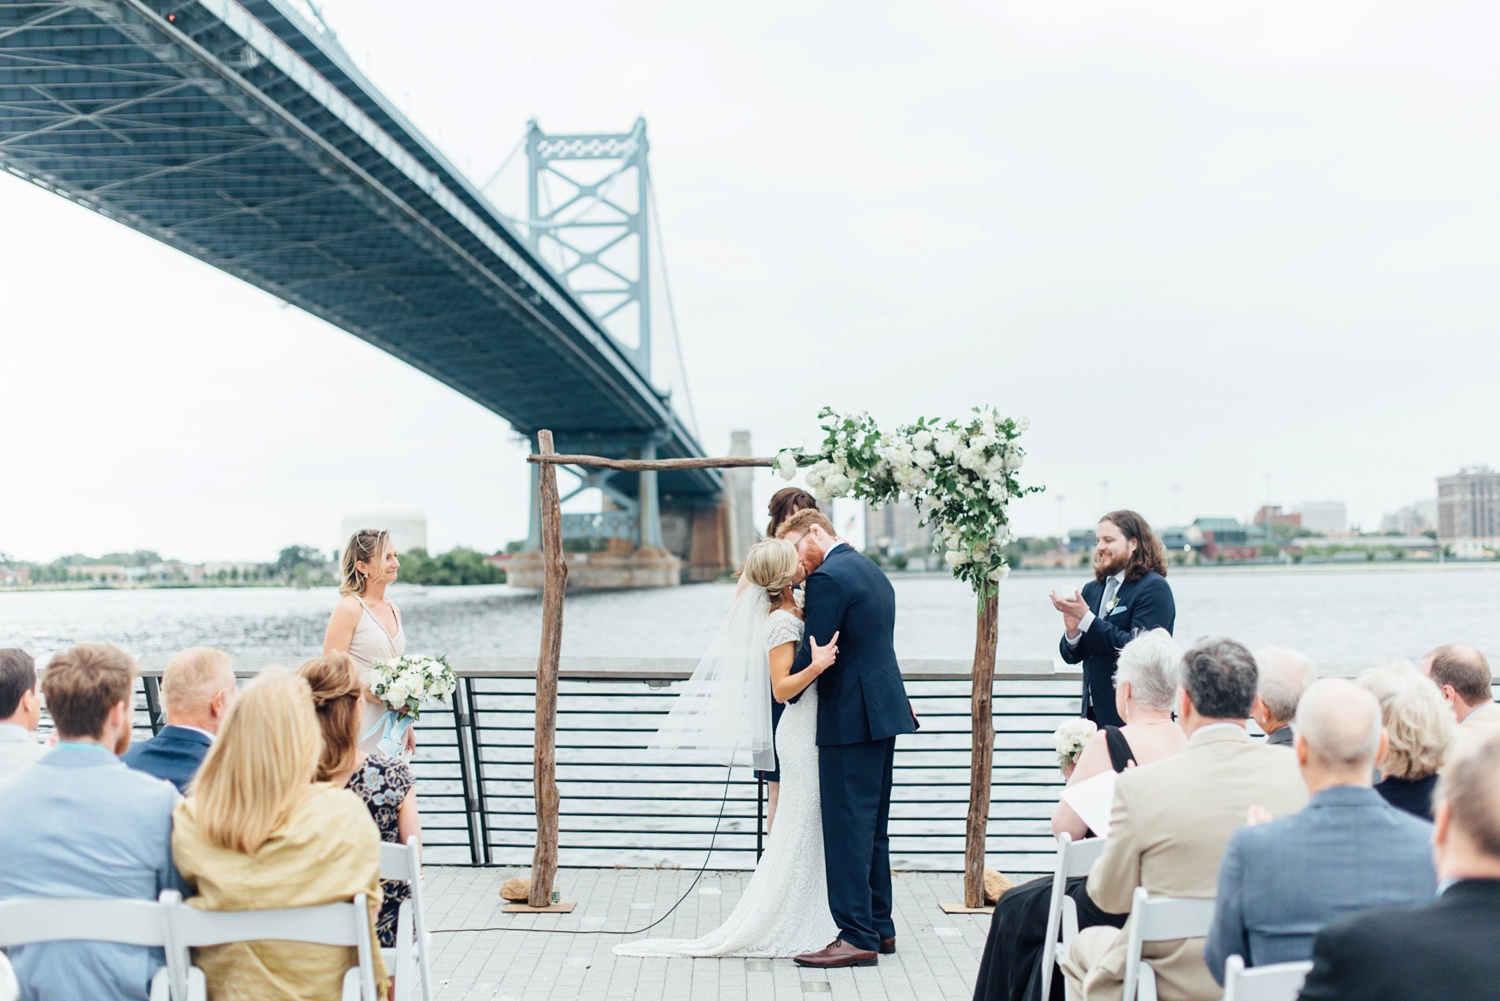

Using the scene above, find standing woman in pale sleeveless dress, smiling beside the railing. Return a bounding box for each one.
[323,528,417,758]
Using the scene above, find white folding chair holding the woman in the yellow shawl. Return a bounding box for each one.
[165,893,381,1001]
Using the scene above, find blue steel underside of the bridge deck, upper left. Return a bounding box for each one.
[0,0,722,506]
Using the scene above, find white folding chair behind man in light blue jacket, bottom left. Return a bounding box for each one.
[0,890,179,1001]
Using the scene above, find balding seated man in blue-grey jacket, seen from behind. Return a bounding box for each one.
[1203,678,1437,983]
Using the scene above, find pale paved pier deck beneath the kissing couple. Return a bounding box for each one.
[423,866,990,1001]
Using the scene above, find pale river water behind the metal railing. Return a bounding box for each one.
[0,563,1500,668]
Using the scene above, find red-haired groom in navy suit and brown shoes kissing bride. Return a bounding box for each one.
[776,509,917,968]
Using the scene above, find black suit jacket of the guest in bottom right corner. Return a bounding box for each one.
[1299,879,1500,1001]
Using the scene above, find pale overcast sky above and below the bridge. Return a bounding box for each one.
[0,0,1500,560]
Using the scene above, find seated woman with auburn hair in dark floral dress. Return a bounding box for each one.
[297,653,422,947]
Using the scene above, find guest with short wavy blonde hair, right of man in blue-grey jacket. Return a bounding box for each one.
[1356,663,1457,821]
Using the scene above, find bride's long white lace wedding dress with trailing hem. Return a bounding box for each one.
[615,609,839,956]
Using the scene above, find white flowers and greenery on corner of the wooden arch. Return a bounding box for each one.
[776,407,1043,599]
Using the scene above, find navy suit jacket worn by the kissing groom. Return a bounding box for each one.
[792,545,917,746]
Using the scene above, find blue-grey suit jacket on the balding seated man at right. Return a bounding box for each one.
[1203,785,1437,983]
